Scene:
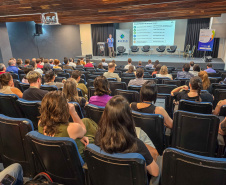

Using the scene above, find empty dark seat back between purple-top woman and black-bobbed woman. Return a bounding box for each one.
[115,89,140,103]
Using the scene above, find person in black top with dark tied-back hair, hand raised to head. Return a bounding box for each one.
[171,76,213,103]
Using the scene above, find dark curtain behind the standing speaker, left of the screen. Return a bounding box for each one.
[91,23,119,56]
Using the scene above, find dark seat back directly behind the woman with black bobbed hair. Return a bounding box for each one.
[132,111,165,155]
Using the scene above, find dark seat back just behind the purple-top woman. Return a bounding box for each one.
[85,104,105,124]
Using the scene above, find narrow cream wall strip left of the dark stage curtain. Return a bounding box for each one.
[80,24,93,56]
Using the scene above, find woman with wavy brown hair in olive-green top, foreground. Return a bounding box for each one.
[38,91,97,157]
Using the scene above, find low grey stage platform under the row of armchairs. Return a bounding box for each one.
[77,54,225,69]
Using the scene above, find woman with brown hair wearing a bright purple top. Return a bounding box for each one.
[89,76,112,107]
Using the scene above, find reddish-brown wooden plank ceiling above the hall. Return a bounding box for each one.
[0,0,226,24]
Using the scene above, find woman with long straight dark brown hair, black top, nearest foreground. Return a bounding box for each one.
[95,96,159,176]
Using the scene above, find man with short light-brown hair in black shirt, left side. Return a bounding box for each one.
[23,71,48,101]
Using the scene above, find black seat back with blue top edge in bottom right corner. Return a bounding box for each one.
[162,148,226,185]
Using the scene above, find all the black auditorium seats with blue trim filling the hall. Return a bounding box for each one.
[0,58,226,185]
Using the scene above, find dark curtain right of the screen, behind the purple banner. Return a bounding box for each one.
[184,18,219,58]
